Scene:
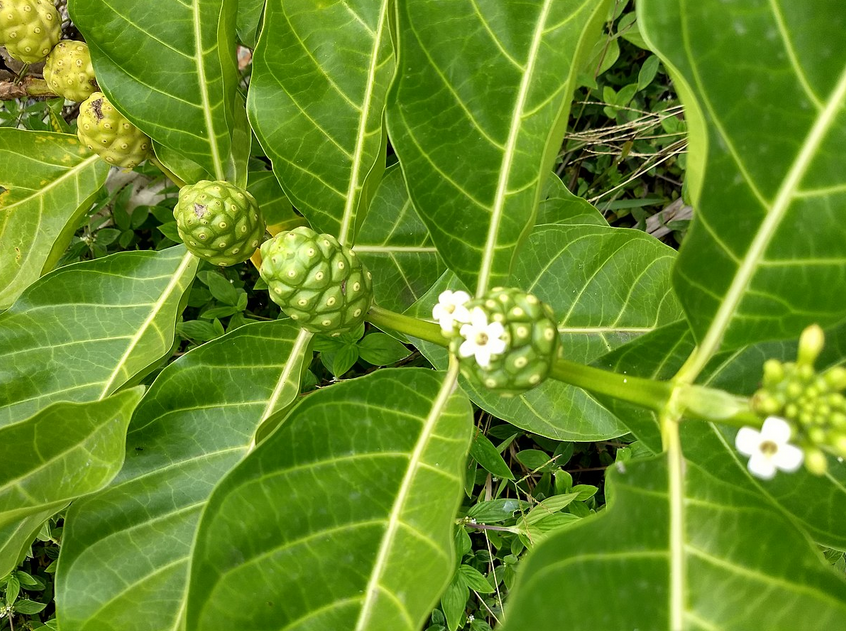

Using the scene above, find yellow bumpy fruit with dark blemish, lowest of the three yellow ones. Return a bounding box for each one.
[77,92,151,169]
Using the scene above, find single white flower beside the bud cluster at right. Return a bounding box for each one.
[734,416,805,480]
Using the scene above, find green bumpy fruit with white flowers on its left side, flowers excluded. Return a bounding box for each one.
[450,287,558,396]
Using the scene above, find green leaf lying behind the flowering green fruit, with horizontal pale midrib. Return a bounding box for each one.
[412,222,682,441]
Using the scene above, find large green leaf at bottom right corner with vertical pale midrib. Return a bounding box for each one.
[504,456,846,631]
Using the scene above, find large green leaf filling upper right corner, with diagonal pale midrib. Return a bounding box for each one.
[638,0,846,356]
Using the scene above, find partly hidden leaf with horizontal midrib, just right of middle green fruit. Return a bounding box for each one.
[355,166,446,311]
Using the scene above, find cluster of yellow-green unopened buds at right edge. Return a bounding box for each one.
[752,325,846,474]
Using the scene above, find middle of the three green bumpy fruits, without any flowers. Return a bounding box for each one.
[260,226,373,335]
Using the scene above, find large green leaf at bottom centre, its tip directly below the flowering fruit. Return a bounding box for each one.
[187,368,472,631]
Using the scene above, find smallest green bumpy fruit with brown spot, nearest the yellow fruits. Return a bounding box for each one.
[173,180,265,267]
